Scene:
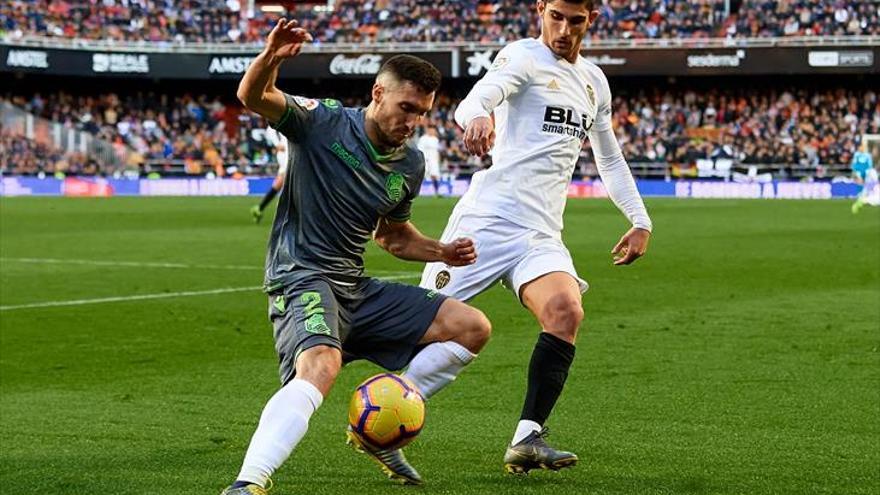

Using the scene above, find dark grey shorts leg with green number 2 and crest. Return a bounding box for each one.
[269,276,342,384]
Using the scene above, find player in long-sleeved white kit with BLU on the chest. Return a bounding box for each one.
[421,0,651,473]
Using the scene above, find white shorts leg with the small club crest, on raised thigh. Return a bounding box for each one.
[419,212,529,301]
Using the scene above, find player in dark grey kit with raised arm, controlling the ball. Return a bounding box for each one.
[223,19,490,495]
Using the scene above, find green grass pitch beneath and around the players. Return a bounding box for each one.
[0,198,880,495]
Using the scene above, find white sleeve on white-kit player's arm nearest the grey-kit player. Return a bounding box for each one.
[455,44,533,129]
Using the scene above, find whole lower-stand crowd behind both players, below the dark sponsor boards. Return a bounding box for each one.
[2,88,880,175]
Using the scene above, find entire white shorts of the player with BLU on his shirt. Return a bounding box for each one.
[419,208,589,301]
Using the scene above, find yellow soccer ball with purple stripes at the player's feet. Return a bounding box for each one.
[348,373,425,449]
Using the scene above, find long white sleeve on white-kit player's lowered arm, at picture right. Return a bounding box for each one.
[587,71,653,232]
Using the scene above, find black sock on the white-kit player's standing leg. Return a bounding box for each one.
[520,332,574,425]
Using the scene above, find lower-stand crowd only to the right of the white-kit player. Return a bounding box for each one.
[614,88,880,173]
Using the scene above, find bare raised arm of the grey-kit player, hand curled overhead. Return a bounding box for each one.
[236,19,312,122]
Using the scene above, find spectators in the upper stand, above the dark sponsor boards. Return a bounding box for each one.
[0,0,880,43]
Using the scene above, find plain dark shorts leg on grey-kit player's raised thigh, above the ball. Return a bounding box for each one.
[343,279,446,370]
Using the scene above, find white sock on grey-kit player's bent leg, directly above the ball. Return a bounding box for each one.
[403,341,477,399]
